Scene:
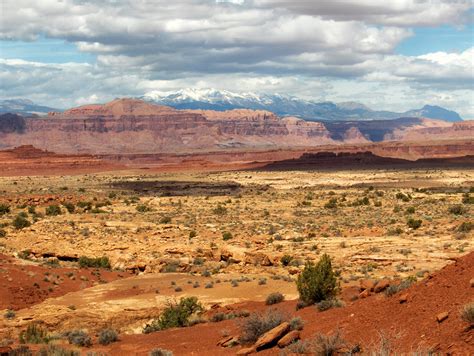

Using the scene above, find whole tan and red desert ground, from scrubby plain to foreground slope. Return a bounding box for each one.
[0,169,474,355]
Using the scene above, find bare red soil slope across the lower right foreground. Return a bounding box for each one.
[85,252,474,355]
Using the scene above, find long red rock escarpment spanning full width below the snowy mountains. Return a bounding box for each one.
[0,99,474,155]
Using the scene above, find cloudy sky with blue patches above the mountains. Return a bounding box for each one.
[0,0,474,119]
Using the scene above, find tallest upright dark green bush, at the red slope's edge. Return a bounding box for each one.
[296,254,338,304]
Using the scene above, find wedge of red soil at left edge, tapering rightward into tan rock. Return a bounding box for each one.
[0,254,131,310]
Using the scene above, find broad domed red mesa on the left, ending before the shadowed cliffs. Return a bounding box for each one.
[0,99,332,154]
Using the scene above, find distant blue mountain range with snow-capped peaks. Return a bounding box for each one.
[141,88,462,121]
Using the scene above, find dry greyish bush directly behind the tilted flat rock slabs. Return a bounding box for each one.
[239,310,286,344]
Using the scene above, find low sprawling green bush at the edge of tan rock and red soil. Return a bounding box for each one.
[143,297,204,334]
